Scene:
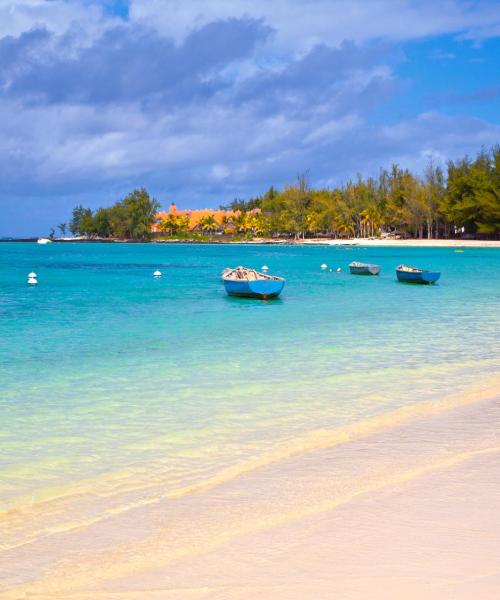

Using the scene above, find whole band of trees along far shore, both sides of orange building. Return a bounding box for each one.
[59,145,500,240]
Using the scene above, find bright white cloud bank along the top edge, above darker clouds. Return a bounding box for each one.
[130,0,500,53]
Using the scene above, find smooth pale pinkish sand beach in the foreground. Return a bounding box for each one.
[2,377,500,600]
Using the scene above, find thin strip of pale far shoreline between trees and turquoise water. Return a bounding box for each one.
[0,237,500,248]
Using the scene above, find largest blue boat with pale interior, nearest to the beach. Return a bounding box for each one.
[222,267,285,300]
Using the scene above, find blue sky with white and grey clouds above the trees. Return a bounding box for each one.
[0,0,500,237]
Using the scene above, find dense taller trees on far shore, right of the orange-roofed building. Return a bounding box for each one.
[221,145,500,239]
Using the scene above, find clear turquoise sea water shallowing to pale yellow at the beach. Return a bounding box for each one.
[0,243,500,596]
